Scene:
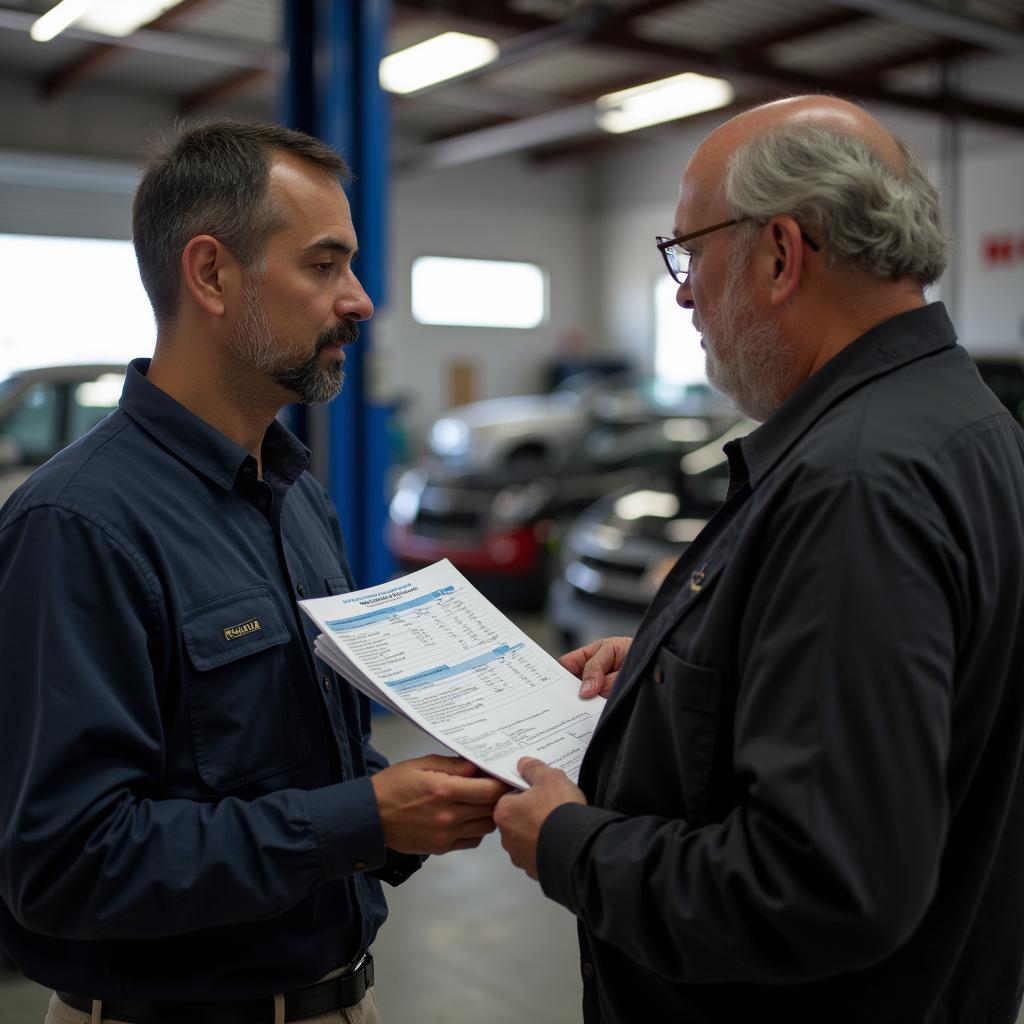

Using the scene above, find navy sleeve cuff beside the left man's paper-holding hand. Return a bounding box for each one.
[309,776,387,882]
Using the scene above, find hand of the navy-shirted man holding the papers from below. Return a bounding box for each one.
[370,754,510,853]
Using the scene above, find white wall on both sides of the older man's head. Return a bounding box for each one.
[596,77,1024,368]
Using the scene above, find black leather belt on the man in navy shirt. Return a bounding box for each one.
[57,953,374,1024]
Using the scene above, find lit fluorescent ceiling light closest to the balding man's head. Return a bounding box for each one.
[597,72,735,135]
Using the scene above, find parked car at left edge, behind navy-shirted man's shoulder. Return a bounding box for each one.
[0,364,125,503]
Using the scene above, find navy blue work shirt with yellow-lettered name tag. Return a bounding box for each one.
[0,359,419,1000]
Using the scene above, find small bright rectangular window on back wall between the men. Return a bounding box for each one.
[413,256,548,330]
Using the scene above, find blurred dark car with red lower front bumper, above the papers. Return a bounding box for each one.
[388,407,736,608]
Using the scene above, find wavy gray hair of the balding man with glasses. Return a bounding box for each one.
[724,124,949,287]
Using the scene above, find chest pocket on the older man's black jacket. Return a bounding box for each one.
[608,647,722,826]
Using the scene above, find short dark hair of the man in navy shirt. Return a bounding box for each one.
[132,120,351,324]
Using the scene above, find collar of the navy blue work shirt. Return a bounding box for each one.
[119,359,309,490]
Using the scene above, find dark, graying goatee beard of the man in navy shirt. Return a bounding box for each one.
[230,280,350,406]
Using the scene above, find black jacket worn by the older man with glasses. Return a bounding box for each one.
[539,305,1024,1024]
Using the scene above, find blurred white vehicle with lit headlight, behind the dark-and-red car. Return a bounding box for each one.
[427,373,724,473]
